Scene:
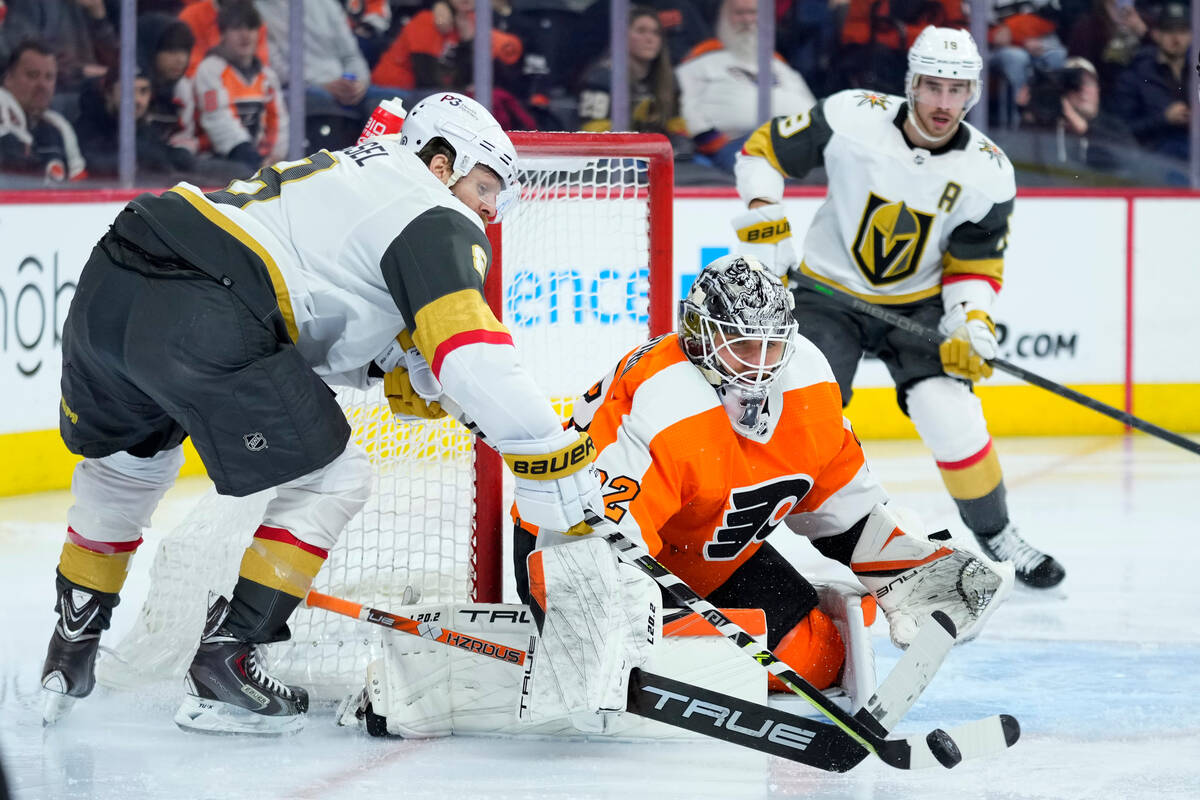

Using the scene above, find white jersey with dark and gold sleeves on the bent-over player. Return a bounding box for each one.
[131,137,562,441]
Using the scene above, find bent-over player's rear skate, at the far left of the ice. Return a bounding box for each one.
[42,587,107,724]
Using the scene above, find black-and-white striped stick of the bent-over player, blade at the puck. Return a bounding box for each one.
[604,518,1020,769]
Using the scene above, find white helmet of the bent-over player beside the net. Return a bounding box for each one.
[400,92,521,222]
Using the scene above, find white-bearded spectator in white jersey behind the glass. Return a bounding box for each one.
[676,0,816,172]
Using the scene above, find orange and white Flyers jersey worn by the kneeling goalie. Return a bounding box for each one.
[572,335,887,595]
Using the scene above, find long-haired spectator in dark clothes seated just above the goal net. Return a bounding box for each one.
[580,6,691,156]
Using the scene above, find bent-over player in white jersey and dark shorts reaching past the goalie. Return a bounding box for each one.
[42,92,602,733]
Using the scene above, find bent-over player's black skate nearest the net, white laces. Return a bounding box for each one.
[175,597,308,735]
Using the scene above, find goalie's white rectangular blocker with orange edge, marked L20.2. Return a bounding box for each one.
[518,536,662,732]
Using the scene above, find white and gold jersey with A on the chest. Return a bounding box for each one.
[737,90,1016,303]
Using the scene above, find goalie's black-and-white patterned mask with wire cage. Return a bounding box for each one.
[679,255,796,431]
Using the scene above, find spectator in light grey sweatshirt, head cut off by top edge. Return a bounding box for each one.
[254,0,395,149]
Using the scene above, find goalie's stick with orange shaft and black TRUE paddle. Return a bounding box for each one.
[305,591,868,772]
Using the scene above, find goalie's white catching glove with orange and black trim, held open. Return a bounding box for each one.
[850,504,1014,649]
